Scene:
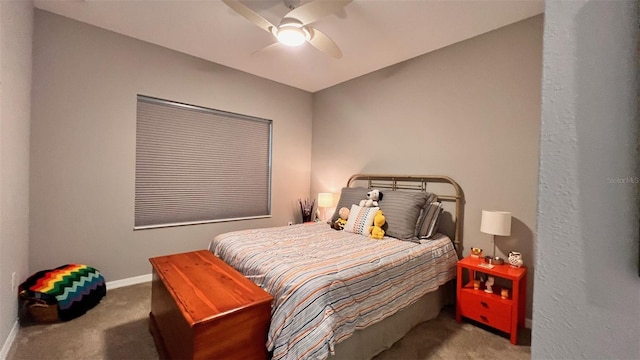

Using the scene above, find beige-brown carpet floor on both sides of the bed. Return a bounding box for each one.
[7,283,531,360]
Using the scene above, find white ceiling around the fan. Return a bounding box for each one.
[34,0,544,92]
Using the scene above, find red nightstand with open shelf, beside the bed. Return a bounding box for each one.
[456,256,527,345]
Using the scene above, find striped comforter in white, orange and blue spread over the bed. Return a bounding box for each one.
[209,224,457,359]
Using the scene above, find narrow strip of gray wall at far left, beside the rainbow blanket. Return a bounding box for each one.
[0,0,33,358]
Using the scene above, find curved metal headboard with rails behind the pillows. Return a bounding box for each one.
[347,174,464,257]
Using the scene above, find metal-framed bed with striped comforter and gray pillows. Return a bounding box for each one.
[209,174,464,360]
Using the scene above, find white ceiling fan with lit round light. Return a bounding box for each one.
[222,0,352,58]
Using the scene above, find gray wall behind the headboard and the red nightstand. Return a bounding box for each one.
[311,15,543,317]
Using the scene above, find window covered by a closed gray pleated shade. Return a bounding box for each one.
[134,95,272,229]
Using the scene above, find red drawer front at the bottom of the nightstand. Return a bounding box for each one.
[459,289,512,332]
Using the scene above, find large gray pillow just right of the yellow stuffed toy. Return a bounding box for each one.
[378,191,430,240]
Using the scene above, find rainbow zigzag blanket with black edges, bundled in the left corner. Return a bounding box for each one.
[20,264,107,321]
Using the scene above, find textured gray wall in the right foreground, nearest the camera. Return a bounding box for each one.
[532,1,640,359]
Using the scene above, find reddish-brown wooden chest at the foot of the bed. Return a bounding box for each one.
[149,250,273,359]
